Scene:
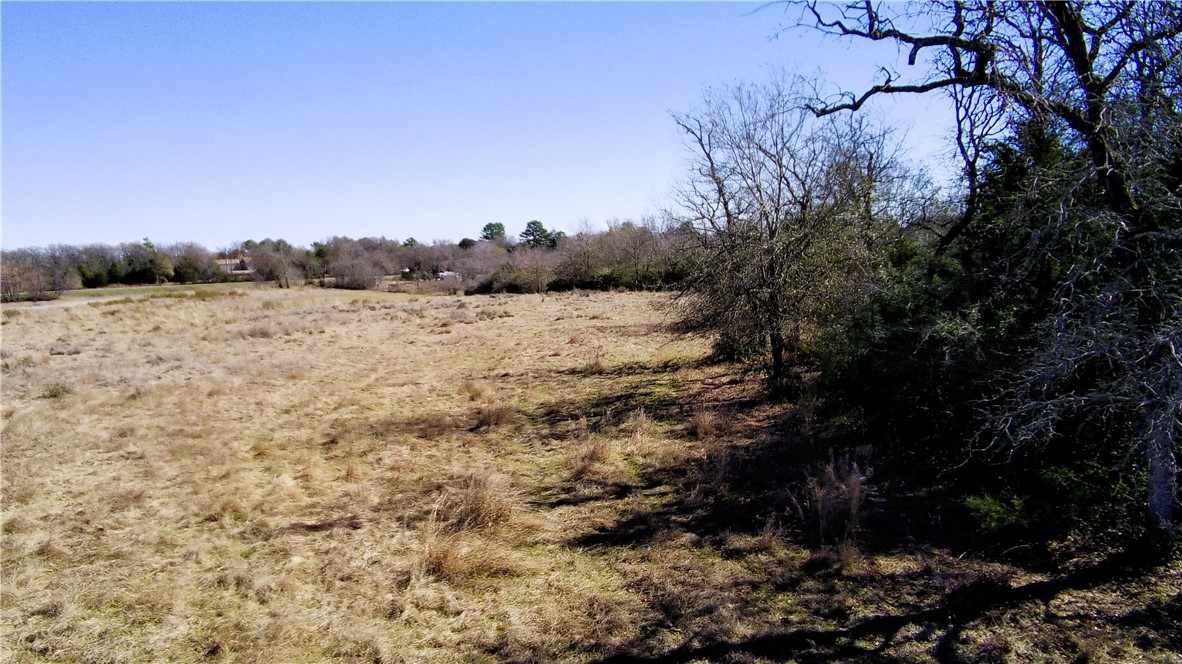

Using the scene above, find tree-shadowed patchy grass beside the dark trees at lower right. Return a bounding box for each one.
[524,365,1182,663]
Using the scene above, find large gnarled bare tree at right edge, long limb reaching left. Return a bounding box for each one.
[790,0,1182,530]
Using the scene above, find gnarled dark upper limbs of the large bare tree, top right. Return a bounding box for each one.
[804,1,1182,217]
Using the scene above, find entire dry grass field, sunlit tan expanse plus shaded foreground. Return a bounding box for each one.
[0,286,1182,663]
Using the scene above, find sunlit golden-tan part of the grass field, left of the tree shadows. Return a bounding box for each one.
[0,287,695,662]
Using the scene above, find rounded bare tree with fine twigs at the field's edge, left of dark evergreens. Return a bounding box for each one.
[675,79,912,390]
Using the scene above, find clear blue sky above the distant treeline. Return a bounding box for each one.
[0,1,949,249]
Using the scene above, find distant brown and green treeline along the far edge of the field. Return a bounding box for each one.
[0,219,693,301]
